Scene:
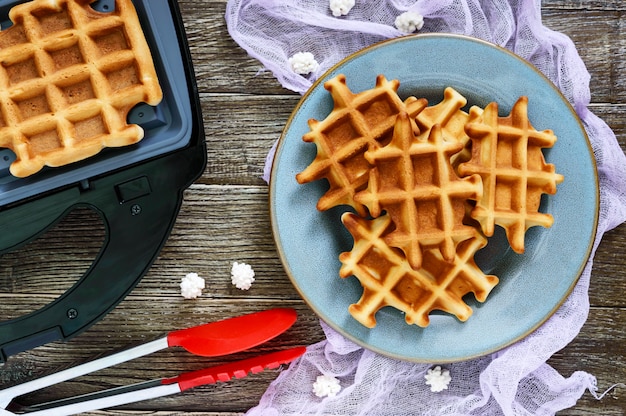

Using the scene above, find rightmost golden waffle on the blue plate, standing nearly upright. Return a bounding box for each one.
[458,97,563,253]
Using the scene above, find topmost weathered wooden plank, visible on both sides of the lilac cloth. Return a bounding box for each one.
[180,0,626,102]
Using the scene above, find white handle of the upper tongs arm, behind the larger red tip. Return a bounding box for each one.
[0,337,168,414]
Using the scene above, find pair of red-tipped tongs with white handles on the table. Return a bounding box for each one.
[0,308,306,416]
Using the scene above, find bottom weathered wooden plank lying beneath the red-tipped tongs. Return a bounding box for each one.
[0,296,322,412]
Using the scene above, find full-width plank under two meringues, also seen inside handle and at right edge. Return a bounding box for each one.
[0,185,626,308]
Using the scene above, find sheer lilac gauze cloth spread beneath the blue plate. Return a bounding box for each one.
[226,0,626,416]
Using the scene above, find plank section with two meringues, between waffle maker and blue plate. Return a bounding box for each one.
[143,185,299,299]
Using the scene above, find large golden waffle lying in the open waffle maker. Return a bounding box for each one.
[0,0,162,177]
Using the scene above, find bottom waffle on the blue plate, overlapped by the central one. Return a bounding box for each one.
[339,213,498,328]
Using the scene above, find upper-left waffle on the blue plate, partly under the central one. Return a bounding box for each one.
[296,75,427,215]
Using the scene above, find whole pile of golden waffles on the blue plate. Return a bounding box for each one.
[296,75,563,328]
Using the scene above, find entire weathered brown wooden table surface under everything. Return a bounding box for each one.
[0,0,626,416]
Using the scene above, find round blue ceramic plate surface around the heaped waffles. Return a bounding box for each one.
[270,34,599,363]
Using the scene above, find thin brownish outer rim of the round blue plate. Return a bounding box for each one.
[268,33,600,364]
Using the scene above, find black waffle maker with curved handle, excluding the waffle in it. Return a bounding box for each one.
[0,0,206,362]
